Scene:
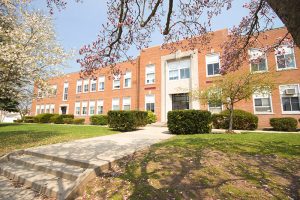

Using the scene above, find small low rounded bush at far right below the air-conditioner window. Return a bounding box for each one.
[270,117,298,131]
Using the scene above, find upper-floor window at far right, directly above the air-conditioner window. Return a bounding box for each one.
[275,46,296,70]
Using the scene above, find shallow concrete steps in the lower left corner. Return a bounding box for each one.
[0,151,91,199]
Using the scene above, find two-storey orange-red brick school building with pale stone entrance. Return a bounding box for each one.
[32,28,300,128]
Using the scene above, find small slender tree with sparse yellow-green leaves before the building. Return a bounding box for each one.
[191,70,275,133]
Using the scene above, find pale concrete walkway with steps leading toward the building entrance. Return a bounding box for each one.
[0,127,173,200]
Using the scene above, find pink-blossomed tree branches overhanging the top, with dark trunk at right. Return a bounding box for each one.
[42,0,300,75]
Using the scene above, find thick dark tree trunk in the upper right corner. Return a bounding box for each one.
[266,0,300,47]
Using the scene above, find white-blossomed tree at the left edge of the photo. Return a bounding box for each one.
[0,3,69,104]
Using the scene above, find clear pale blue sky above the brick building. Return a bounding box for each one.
[32,0,283,73]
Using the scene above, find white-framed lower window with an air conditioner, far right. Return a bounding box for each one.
[279,85,300,114]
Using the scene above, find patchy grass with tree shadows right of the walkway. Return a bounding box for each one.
[83,133,300,199]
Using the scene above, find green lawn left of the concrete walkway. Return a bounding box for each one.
[0,123,117,156]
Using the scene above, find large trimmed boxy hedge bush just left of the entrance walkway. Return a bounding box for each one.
[108,111,147,131]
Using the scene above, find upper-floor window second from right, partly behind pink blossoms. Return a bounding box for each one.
[249,49,267,72]
